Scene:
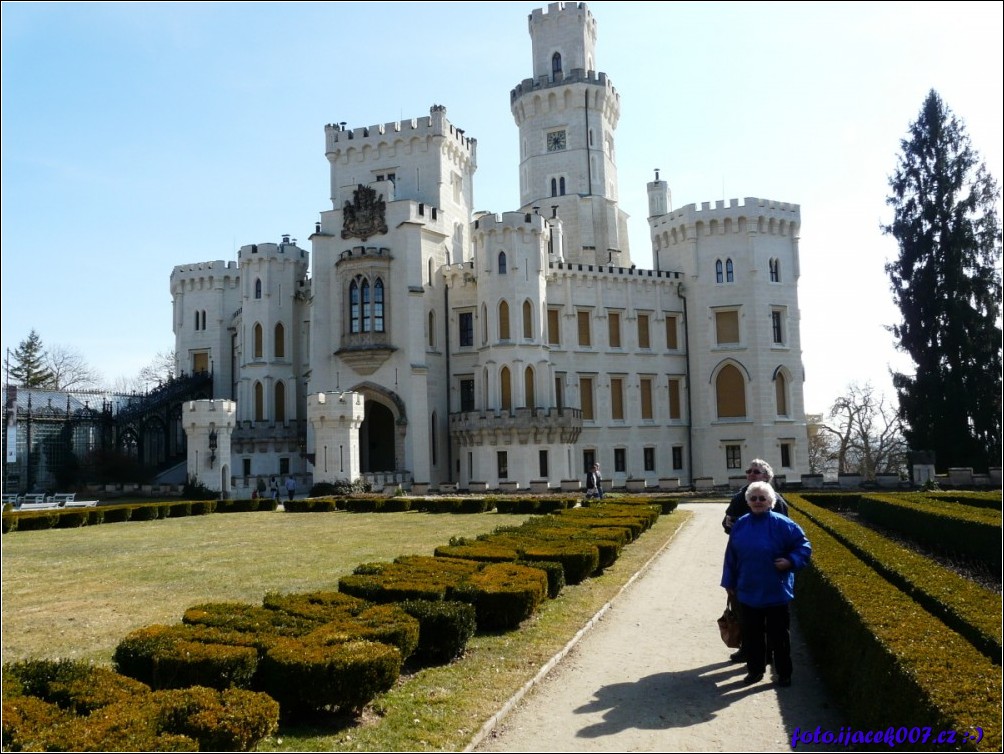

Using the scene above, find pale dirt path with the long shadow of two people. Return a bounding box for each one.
[473,503,841,752]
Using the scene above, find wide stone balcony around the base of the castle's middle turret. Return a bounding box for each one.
[450,408,582,445]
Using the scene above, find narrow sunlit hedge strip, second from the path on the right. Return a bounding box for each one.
[787,494,1004,665]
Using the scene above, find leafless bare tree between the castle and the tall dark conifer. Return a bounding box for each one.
[821,383,907,480]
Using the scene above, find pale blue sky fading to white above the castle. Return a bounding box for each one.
[0,2,1004,412]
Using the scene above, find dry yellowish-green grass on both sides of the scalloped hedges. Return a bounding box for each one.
[2,504,690,751]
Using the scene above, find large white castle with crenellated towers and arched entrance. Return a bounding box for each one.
[171,3,808,494]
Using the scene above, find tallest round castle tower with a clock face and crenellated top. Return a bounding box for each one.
[510,2,632,267]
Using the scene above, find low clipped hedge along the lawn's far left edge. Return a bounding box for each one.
[3,498,277,534]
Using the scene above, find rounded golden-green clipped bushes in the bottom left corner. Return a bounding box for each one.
[3,660,279,751]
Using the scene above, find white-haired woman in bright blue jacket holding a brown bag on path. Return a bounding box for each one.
[722,482,812,686]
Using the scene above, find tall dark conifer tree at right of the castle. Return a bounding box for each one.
[883,89,1001,470]
